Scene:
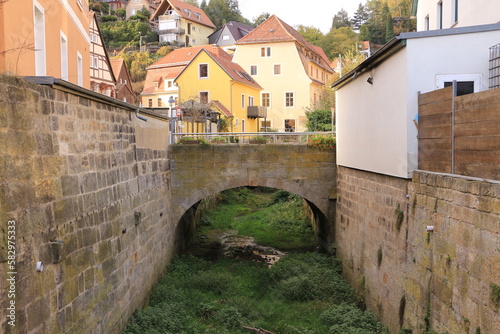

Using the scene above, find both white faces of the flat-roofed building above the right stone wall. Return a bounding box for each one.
[336,30,500,178]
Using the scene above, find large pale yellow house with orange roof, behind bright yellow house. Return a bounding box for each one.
[233,15,333,132]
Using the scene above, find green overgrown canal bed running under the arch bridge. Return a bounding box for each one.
[124,188,387,334]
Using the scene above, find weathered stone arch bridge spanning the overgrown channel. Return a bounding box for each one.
[168,144,337,247]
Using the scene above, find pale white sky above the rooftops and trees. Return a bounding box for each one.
[238,0,366,34]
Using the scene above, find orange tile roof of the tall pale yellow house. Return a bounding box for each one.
[236,15,333,73]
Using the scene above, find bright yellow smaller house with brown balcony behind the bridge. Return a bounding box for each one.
[174,45,262,132]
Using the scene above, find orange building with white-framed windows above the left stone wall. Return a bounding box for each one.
[0,0,90,88]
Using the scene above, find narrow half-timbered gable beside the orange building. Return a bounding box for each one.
[89,12,116,97]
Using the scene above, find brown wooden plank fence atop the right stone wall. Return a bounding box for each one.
[418,87,500,180]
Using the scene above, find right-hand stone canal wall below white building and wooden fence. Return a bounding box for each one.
[336,166,500,333]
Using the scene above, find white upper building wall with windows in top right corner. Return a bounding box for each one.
[417,0,500,31]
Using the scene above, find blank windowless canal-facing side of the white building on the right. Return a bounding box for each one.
[336,49,416,178]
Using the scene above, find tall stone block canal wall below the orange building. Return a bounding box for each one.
[0,76,175,333]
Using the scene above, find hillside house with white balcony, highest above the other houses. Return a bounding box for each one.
[151,0,215,46]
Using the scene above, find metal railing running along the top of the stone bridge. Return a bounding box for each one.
[171,131,335,144]
